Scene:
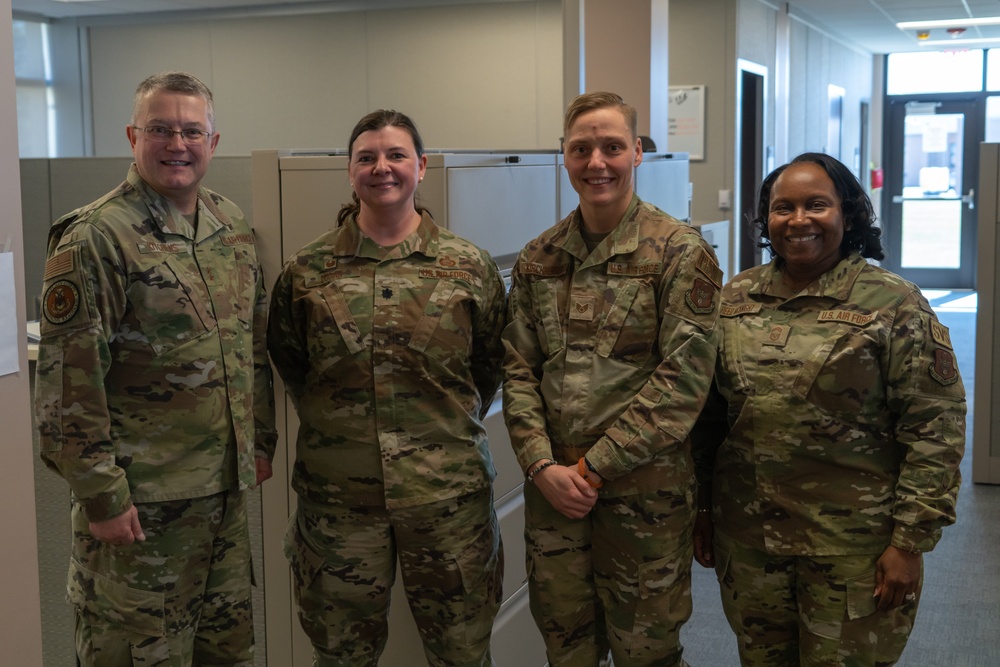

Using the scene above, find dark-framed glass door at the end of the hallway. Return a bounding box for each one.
[883,100,983,289]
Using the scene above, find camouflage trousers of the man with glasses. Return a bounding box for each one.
[68,491,254,667]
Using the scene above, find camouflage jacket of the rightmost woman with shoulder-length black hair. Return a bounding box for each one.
[695,254,965,556]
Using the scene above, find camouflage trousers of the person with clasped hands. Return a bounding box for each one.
[524,483,694,667]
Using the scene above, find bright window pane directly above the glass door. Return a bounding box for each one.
[886,50,983,95]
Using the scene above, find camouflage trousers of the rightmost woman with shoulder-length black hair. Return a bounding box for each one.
[713,530,923,667]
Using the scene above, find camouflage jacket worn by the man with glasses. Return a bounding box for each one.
[35,165,277,521]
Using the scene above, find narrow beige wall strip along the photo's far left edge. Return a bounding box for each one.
[0,0,42,665]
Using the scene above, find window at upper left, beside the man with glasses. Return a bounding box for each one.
[13,21,55,157]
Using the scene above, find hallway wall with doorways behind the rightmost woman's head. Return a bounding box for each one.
[669,0,880,243]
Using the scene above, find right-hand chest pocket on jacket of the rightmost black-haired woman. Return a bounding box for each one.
[792,325,885,416]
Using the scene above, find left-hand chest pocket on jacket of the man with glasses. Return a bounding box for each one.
[126,260,215,355]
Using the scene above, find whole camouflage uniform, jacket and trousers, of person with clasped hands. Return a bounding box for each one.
[504,196,722,667]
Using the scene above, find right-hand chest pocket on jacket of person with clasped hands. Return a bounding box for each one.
[594,280,659,366]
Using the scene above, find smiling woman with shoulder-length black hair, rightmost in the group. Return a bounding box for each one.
[692,153,966,667]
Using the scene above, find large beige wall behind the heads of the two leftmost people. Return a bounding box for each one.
[87,0,563,156]
